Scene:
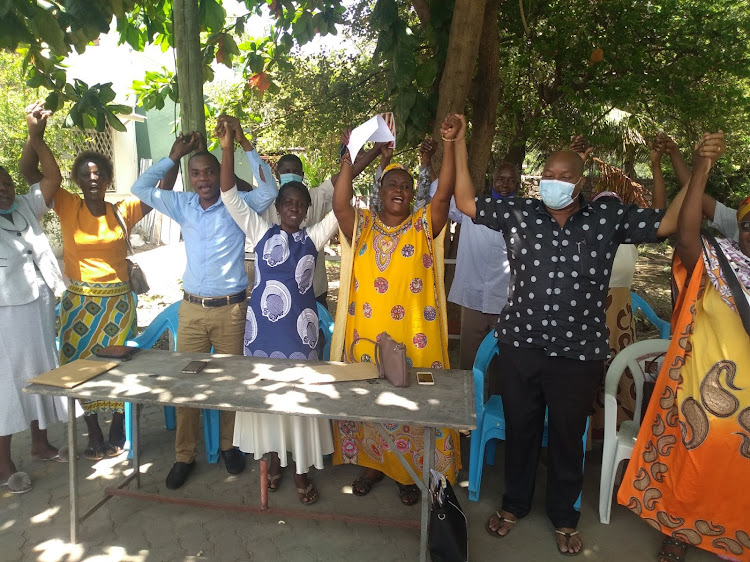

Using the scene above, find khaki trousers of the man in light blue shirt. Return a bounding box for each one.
[174,301,247,463]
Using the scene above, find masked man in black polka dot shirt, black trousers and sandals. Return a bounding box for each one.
[455,116,682,554]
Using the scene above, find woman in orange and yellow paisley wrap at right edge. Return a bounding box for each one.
[617,132,750,562]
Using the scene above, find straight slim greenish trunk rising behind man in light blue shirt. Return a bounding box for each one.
[172,0,206,189]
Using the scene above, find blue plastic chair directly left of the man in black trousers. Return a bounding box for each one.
[469,330,589,511]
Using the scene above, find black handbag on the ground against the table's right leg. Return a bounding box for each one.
[427,470,469,562]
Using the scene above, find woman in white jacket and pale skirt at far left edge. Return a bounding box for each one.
[0,104,67,494]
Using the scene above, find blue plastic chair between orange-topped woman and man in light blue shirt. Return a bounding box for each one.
[125,301,220,463]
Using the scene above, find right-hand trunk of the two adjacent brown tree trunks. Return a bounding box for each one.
[469,0,501,192]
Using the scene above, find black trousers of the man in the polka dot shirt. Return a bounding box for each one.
[499,343,604,528]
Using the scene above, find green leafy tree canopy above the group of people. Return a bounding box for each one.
[0,0,750,198]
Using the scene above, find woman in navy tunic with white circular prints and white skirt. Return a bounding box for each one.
[217,122,338,505]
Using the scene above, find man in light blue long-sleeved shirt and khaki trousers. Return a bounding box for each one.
[131,133,277,489]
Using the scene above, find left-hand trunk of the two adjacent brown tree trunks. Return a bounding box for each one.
[432,0,487,165]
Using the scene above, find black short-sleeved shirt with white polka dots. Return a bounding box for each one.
[475,197,664,361]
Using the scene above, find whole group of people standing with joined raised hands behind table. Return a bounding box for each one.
[0,101,750,560]
